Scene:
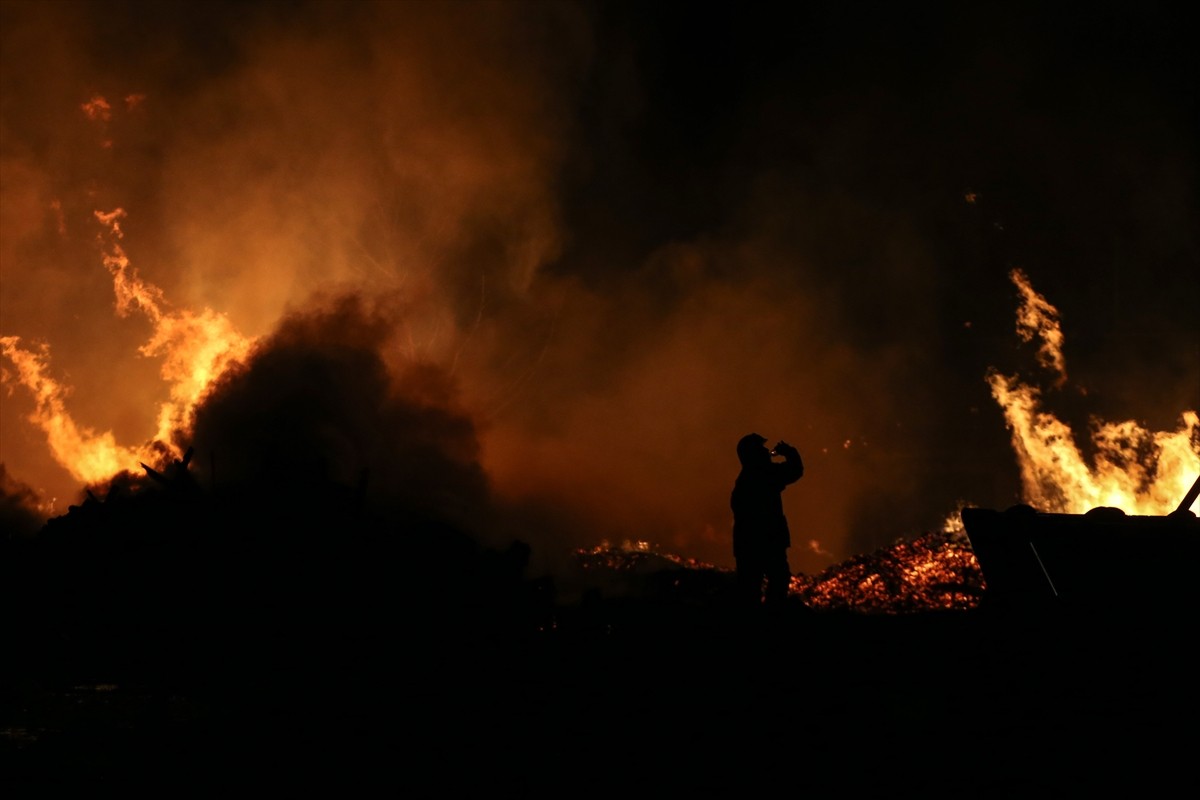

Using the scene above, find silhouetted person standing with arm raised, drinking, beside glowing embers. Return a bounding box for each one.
[730,433,804,608]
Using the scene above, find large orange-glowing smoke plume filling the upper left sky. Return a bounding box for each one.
[2,2,586,537]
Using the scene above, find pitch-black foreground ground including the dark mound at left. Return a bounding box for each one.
[0,473,1198,798]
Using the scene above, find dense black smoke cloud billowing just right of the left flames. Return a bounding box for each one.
[191,291,490,535]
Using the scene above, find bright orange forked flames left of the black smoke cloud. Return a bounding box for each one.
[0,209,253,485]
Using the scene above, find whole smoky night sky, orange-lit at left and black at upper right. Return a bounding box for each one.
[0,0,1200,571]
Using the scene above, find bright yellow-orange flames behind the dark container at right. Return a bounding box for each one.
[988,270,1200,516]
